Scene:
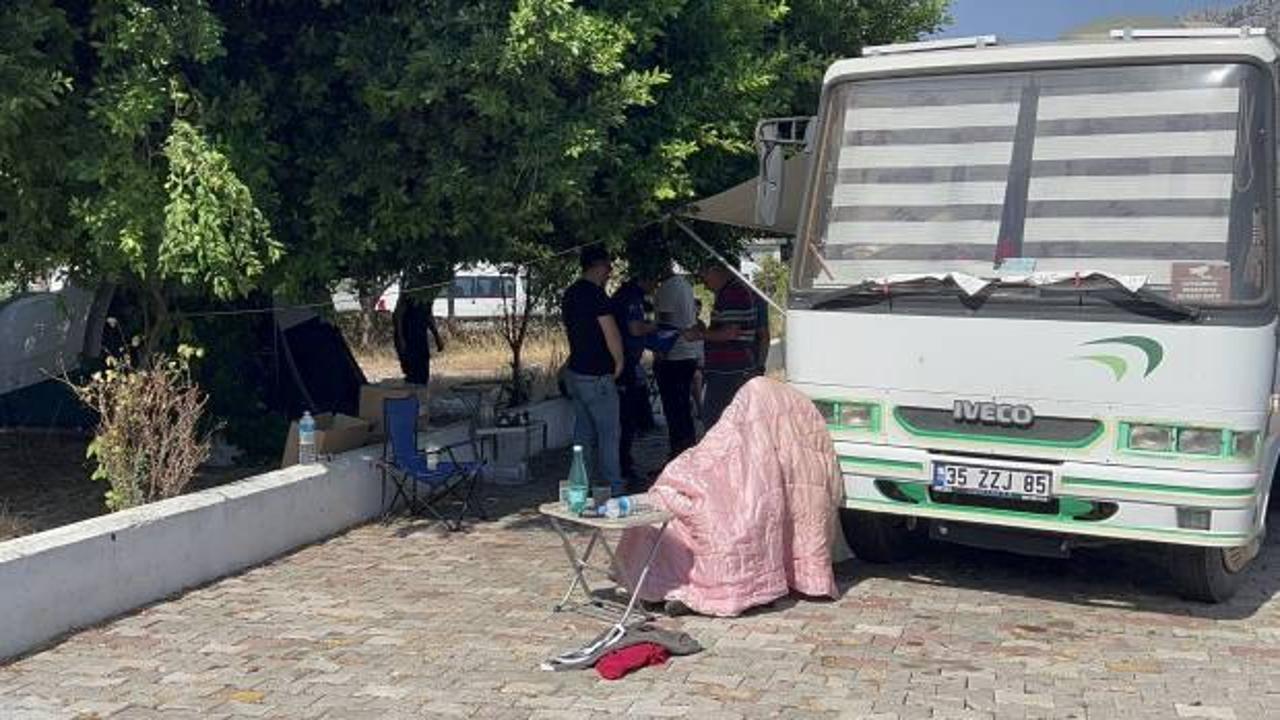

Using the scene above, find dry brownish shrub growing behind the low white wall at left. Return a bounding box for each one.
[76,346,211,510]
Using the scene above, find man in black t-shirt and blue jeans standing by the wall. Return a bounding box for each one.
[561,245,626,496]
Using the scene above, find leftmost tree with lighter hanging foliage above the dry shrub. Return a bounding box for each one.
[0,0,279,356]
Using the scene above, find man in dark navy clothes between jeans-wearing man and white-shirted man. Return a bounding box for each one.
[612,259,658,491]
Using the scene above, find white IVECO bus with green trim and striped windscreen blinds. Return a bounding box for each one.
[786,29,1280,602]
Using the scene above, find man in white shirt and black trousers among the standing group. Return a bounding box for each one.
[654,268,701,457]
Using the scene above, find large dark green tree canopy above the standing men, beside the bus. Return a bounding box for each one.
[252,0,943,392]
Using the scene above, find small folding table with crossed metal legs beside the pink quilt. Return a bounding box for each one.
[538,502,671,628]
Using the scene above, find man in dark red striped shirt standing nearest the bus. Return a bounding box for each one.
[686,261,760,430]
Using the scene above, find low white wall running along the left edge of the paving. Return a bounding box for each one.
[0,400,572,660]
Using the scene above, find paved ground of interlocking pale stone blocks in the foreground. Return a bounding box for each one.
[0,430,1280,720]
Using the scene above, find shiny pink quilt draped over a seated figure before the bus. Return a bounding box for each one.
[618,378,841,616]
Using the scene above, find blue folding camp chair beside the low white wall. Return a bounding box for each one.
[380,395,489,530]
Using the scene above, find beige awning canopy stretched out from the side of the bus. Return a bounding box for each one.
[676,152,812,236]
